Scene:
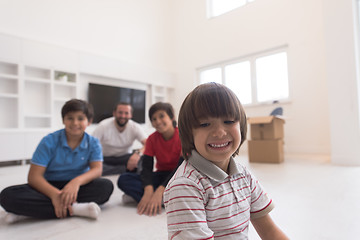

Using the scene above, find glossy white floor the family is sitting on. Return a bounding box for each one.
[0,156,360,240]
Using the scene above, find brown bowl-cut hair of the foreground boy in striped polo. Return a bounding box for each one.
[179,83,247,159]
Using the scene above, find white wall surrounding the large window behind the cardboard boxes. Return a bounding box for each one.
[173,0,330,154]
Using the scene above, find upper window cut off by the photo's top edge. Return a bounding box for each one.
[207,0,254,18]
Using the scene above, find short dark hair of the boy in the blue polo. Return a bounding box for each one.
[61,99,94,122]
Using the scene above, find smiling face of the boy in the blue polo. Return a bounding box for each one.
[63,111,89,137]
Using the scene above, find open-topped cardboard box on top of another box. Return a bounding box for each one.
[248,116,285,140]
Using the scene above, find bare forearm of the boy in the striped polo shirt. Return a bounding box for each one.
[251,214,289,240]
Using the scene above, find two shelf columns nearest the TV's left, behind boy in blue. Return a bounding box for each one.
[20,66,77,129]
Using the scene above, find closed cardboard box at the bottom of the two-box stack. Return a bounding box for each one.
[248,139,284,163]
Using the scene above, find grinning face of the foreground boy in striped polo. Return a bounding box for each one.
[193,118,241,172]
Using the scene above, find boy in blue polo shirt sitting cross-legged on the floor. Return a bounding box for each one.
[0,99,113,223]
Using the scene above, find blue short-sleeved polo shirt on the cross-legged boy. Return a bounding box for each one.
[31,129,103,181]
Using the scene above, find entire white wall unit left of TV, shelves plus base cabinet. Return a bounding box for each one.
[0,60,78,161]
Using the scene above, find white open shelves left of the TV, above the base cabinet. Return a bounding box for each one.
[0,61,78,130]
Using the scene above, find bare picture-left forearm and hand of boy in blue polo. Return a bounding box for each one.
[28,164,67,218]
